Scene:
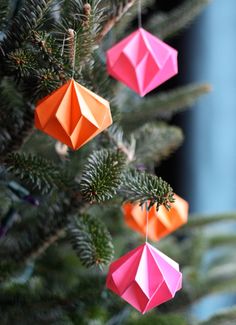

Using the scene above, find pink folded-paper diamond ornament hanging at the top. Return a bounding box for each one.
[107,28,178,96]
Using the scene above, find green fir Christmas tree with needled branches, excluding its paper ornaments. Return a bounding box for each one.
[0,0,236,325]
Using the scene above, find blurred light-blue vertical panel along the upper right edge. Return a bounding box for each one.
[180,0,236,213]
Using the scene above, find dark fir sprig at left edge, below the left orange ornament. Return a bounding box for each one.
[5,153,71,193]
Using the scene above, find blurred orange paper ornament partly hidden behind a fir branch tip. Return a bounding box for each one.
[123,194,188,241]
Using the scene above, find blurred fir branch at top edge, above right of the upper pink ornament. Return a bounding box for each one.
[147,0,211,39]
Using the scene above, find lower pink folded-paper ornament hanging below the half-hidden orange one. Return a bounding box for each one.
[106,243,182,314]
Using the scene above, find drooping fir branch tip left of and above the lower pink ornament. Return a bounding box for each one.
[68,215,114,267]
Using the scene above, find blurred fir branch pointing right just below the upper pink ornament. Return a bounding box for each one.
[123,84,211,127]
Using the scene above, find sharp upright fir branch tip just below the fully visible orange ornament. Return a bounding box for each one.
[80,149,125,202]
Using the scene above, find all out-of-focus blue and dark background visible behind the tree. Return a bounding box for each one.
[157,0,236,318]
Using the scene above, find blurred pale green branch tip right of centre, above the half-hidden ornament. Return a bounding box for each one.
[133,123,183,163]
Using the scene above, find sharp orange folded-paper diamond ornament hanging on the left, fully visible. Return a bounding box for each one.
[35,79,112,150]
